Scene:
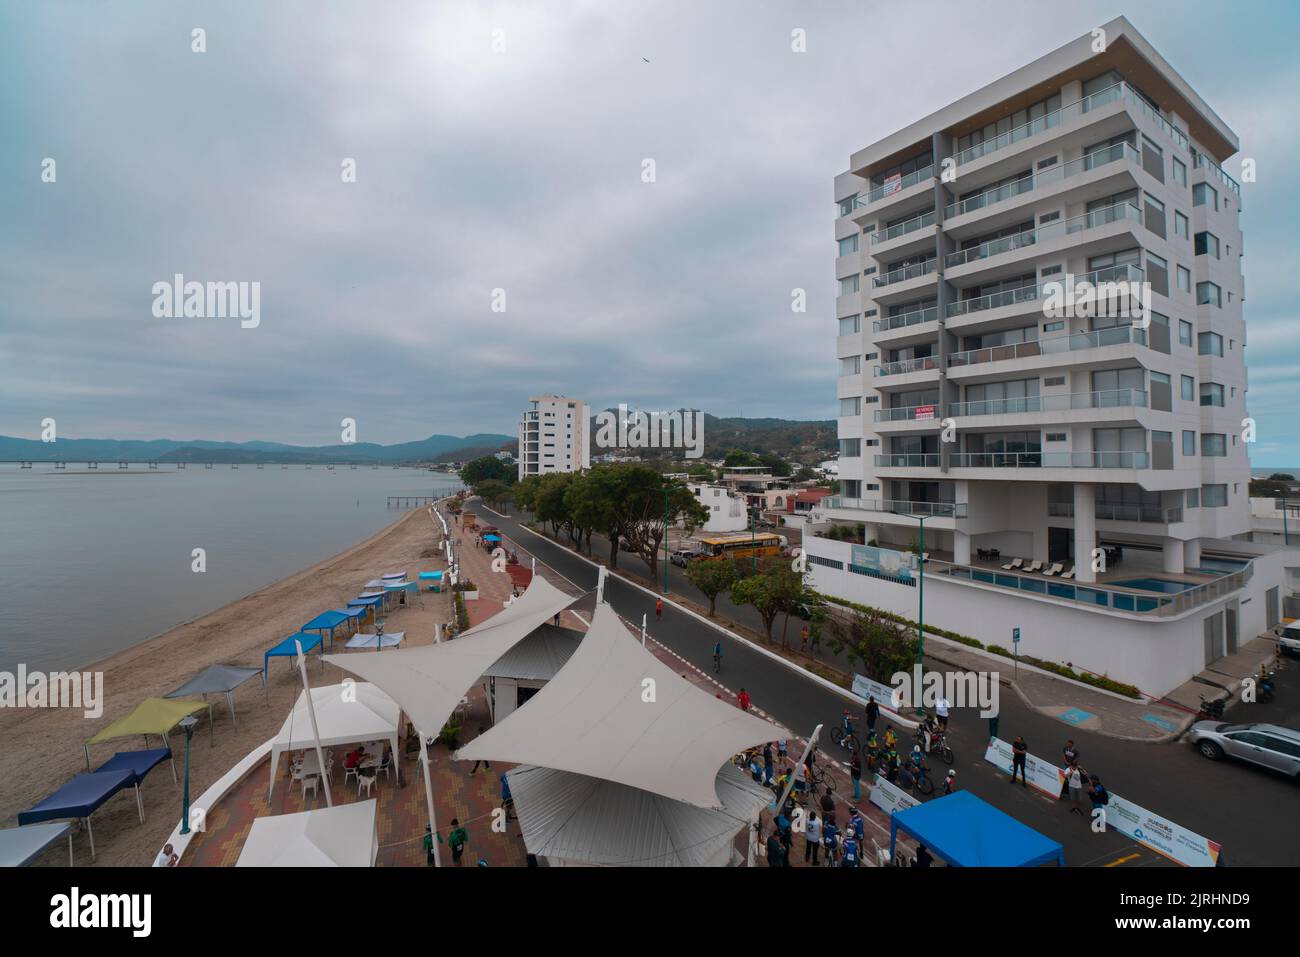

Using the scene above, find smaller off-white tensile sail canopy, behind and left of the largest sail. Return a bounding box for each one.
[325,575,577,739]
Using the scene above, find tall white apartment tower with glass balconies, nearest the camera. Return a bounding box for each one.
[823,18,1251,587]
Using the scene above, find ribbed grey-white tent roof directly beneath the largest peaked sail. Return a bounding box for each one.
[508,765,772,867]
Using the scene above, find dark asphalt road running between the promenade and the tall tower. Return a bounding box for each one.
[478,501,1300,866]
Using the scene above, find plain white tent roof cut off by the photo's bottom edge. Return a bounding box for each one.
[235,800,380,867]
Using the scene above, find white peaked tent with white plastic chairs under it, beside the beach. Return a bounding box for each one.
[267,681,402,800]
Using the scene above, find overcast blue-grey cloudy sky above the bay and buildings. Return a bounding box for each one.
[0,0,1300,465]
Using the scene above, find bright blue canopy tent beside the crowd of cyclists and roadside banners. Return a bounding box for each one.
[889,791,1065,867]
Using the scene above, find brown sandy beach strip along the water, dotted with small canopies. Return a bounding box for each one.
[0,508,452,866]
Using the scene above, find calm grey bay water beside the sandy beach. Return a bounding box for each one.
[0,463,462,671]
